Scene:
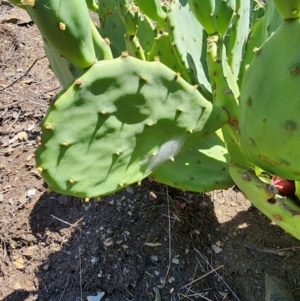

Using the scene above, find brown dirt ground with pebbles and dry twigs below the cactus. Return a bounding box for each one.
[0,1,300,301]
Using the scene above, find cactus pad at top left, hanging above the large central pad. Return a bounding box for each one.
[26,0,96,68]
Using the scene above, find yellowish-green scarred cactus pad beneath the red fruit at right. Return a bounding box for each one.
[229,164,300,239]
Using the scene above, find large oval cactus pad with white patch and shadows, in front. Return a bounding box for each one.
[36,53,228,197]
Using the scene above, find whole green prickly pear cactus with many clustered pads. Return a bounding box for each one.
[6,0,300,239]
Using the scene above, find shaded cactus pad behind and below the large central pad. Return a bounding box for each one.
[151,134,234,192]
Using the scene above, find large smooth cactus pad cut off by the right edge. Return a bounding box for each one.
[240,19,300,181]
